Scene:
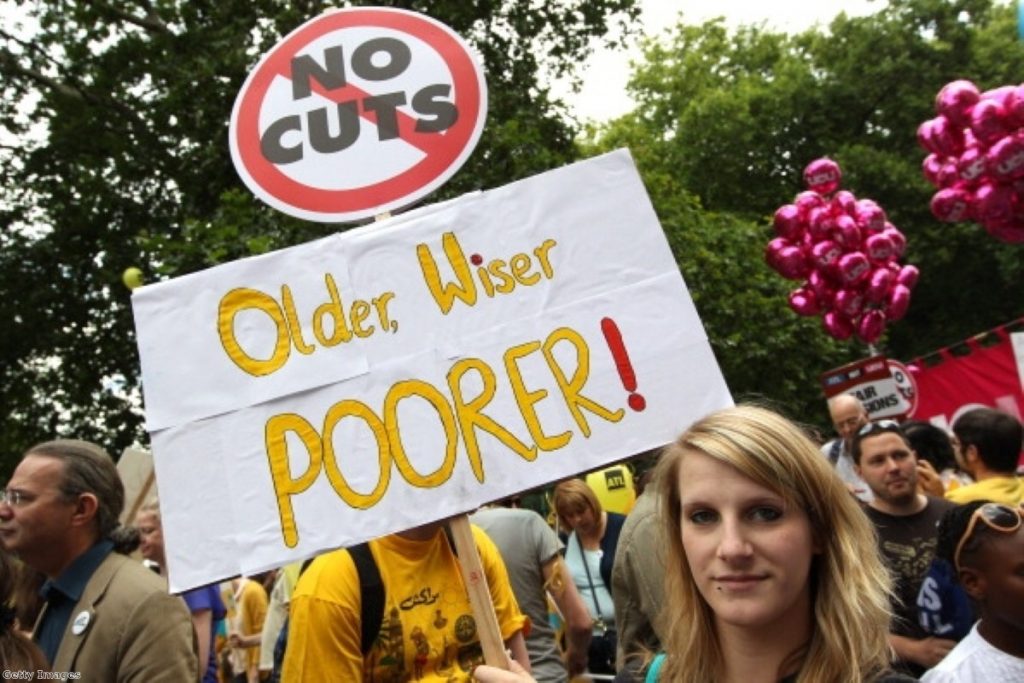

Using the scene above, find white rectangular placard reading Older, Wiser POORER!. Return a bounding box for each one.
[133,151,731,590]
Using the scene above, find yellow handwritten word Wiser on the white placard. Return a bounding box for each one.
[416,232,558,315]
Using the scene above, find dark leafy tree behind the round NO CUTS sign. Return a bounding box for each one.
[0,0,638,469]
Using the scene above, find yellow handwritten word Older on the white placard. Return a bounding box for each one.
[217,273,398,377]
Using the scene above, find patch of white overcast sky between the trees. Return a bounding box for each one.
[566,0,886,121]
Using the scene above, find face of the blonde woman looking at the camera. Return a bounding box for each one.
[677,452,817,629]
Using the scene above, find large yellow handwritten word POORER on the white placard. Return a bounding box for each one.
[264,328,625,548]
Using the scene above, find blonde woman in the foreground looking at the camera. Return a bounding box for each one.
[476,407,913,683]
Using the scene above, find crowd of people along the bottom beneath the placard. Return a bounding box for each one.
[0,403,1024,683]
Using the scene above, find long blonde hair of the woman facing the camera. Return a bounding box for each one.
[656,405,891,683]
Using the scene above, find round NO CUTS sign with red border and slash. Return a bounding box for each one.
[229,7,487,222]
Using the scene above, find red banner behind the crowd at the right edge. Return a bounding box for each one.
[907,318,1024,430]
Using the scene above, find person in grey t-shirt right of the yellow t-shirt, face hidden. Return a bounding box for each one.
[469,505,591,683]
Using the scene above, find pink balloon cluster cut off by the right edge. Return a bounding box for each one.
[918,81,1024,243]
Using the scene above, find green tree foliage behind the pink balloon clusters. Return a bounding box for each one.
[590,0,1024,423]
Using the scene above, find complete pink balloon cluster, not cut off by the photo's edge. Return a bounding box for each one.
[765,159,919,344]
